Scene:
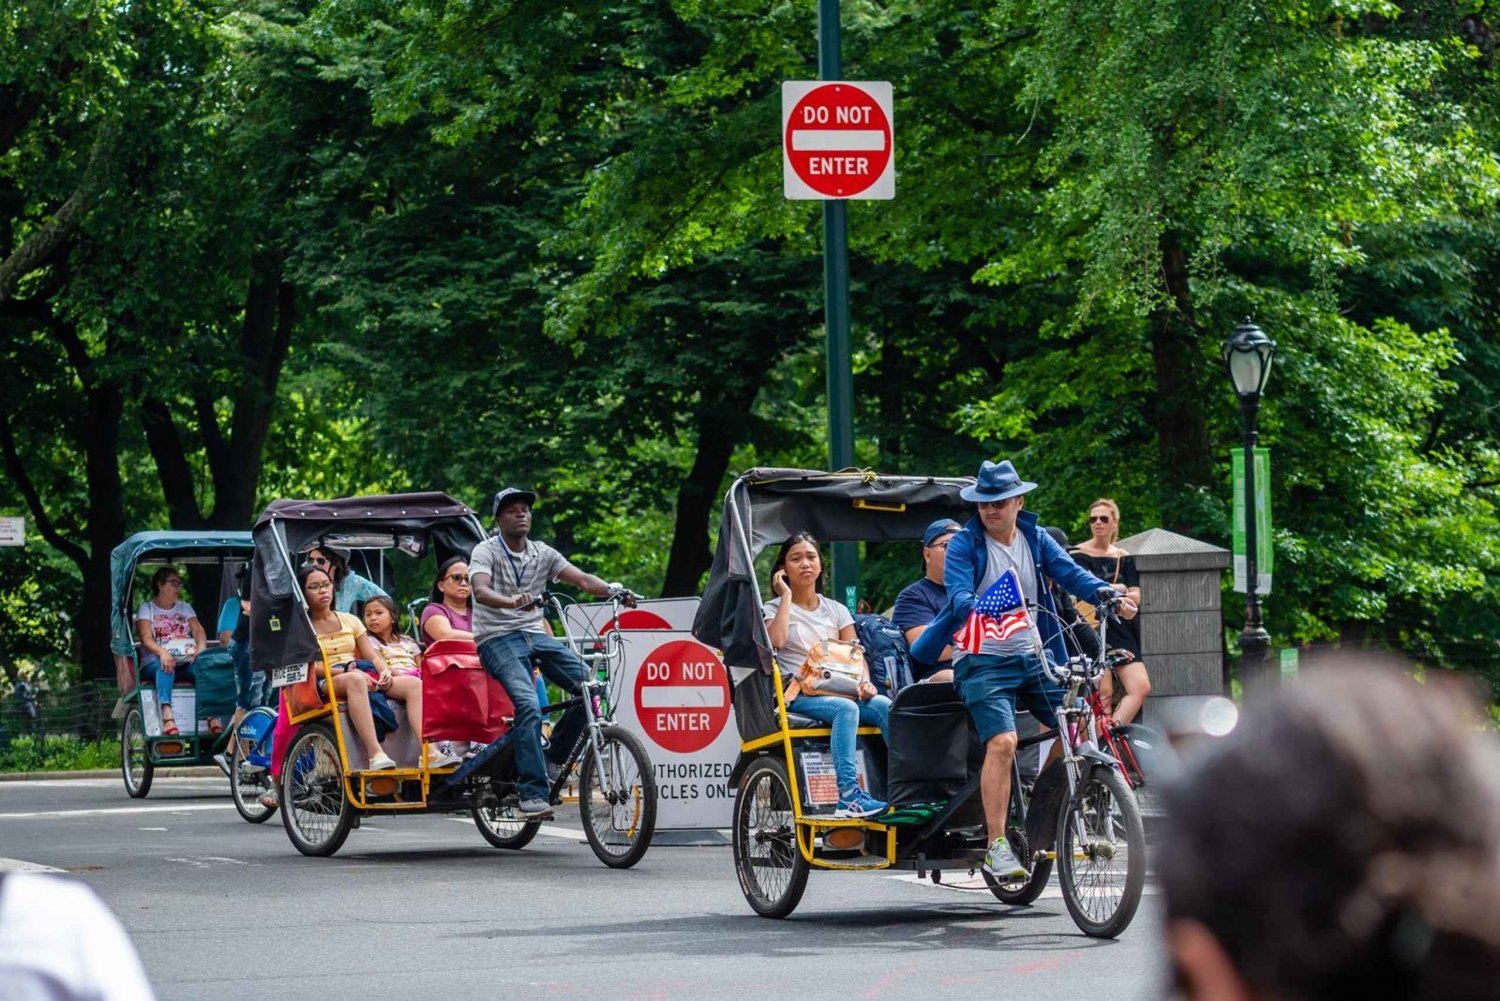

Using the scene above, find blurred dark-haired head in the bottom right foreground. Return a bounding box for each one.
[1157,668,1500,1001]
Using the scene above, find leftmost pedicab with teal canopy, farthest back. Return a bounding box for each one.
[110,531,254,798]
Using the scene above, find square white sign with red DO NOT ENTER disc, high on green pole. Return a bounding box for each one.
[782,80,896,200]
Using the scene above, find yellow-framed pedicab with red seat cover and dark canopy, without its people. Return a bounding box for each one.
[251,492,656,867]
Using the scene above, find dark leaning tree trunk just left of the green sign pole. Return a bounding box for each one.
[662,380,759,597]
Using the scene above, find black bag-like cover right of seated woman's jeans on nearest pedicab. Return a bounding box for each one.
[887,684,983,806]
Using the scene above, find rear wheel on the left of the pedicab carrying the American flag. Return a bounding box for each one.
[734,758,810,917]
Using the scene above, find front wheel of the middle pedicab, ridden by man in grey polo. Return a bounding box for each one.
[578,726,656,869]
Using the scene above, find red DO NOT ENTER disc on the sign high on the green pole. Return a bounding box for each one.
[782,84,891,198]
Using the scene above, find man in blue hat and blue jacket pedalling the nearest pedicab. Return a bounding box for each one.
[912,459,1118,879]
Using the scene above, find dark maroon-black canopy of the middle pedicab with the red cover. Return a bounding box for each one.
[251,492,485,671]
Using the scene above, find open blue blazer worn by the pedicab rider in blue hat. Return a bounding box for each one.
[912,510,1113,665]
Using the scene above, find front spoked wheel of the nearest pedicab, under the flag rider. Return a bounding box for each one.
[1058,767,1146,938]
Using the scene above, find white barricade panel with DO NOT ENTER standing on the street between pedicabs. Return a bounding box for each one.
[615,630,740,830]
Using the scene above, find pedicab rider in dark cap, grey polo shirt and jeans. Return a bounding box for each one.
[470,486,635,819]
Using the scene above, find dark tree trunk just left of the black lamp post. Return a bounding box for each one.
[1151,231,1214,533]
